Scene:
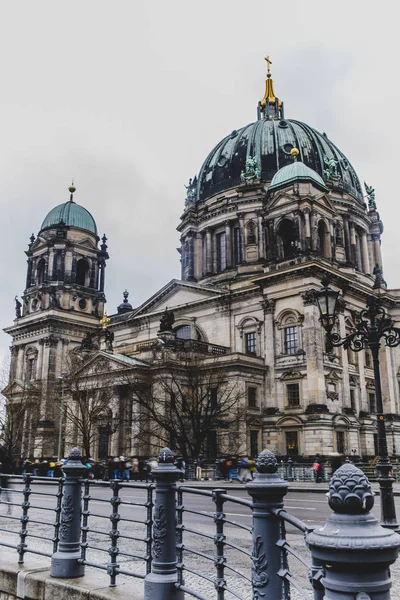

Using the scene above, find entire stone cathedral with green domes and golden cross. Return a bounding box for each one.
[3,57,400,459]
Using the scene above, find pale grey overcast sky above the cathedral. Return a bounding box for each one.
[0,0,400,356]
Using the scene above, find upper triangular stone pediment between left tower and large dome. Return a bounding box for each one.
[132,279,224,317]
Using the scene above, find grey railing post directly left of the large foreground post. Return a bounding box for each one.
[246,450,289,600]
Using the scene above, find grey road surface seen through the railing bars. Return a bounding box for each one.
[0,484,400,598]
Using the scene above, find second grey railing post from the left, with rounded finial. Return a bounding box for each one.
[144,448,184,600]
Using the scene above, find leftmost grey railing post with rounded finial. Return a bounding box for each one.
[50,448,86,578]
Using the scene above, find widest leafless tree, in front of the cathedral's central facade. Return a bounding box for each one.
[126,355,244,460]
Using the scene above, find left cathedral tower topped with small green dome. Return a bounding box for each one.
[5,185,109,456]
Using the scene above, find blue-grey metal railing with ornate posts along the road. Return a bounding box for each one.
[0,449,400,600]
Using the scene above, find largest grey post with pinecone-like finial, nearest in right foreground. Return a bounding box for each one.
[306,463,400,600]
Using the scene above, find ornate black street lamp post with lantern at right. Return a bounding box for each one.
[315,280,400,529]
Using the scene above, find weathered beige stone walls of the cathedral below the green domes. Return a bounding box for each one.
[6,68,400,457]
